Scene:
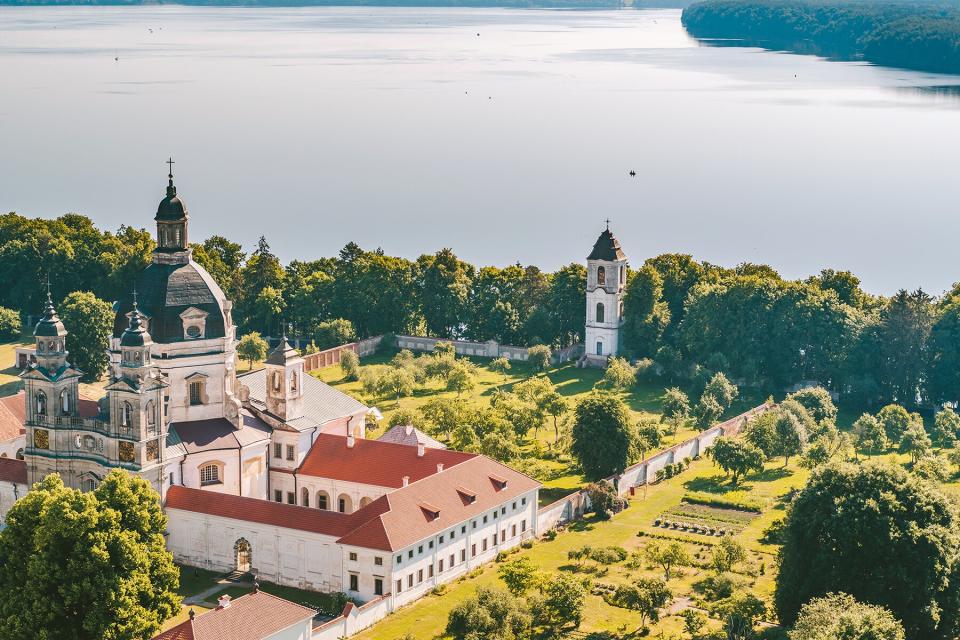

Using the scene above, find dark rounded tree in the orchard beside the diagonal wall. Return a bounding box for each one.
[570,393,637,480]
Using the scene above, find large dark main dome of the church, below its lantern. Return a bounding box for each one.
[113,260,227,344]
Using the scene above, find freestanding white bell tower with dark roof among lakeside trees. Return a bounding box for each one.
[585,220,627,366]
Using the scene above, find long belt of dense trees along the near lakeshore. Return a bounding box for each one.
[0,213,960,408]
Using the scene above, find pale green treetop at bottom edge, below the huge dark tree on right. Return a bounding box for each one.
[787,593,904,640]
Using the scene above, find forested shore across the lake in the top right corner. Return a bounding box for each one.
[683,0,960,73]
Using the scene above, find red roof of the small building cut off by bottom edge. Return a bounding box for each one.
[153,591,317,640]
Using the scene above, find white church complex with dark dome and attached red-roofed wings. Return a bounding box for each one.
[0,169,540,609]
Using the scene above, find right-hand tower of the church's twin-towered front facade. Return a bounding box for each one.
[107,294,168,491]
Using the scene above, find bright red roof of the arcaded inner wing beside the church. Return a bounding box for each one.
[297,434,477,489]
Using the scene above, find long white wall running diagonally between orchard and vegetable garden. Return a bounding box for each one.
[537,403,773,535]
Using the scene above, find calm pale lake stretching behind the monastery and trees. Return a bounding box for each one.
[0,6,960,293]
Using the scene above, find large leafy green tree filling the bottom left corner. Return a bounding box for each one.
[0,470,180,640]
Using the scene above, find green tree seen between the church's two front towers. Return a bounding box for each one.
[59,291,113,382]
